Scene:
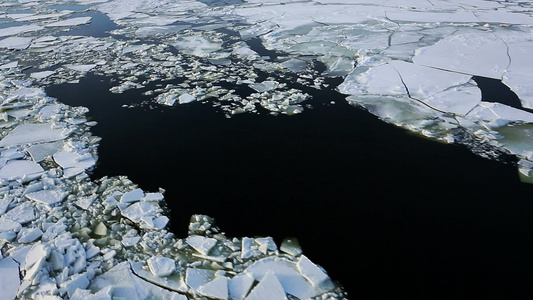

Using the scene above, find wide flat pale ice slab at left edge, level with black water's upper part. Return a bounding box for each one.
[0,123,67,147]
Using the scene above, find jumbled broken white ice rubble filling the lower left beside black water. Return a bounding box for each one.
[0,74,344,299]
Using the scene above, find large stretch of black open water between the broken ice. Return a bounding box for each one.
[47,75,533,299]
